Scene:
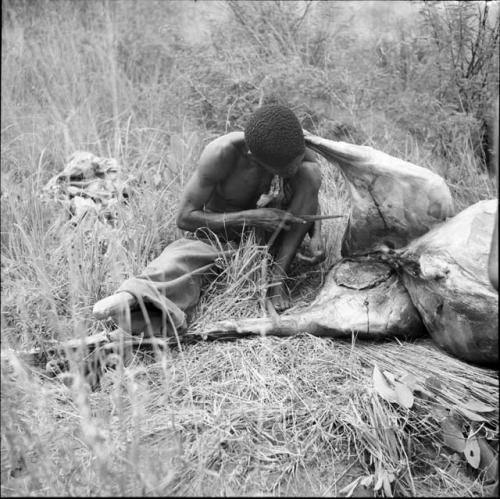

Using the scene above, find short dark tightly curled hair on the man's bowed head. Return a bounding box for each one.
[245,105,305,168]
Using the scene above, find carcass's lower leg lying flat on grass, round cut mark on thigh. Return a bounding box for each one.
[204,257,425,340]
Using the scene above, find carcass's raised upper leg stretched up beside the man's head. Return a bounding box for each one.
[305,132,454,256]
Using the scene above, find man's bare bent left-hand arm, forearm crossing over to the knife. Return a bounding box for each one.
[176,139,305,233]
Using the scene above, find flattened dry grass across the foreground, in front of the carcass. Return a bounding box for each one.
[2,336,498,496]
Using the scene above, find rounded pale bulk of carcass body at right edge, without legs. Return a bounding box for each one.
[396,199,498,364]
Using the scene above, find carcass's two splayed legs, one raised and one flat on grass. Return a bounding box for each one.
[199,137,453,339]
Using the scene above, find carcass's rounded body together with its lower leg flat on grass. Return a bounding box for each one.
[201,200,498,365]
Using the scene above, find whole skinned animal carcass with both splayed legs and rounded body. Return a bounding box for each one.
[201,134,498,363]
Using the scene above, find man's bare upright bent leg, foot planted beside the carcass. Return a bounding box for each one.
[269,163,321,310]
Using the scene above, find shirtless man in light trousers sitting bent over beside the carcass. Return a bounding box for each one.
[94,105,324,334]
